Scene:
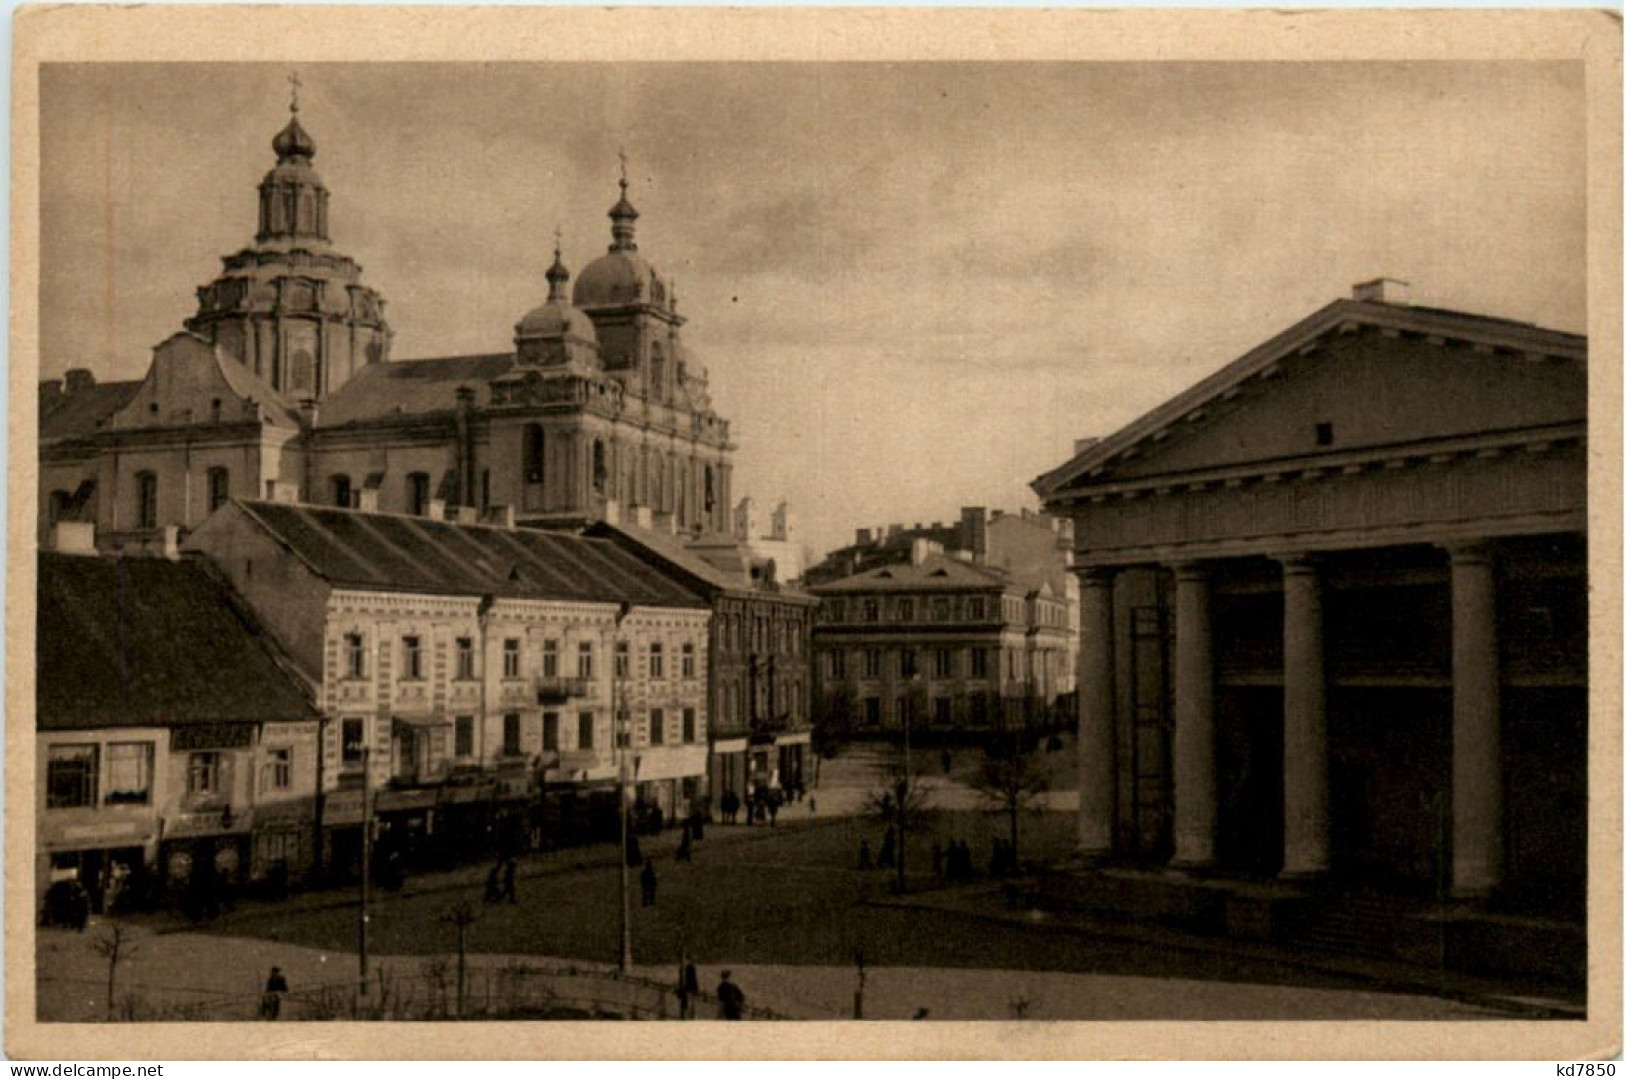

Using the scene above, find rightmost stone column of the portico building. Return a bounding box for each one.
[1450,543,1503,899]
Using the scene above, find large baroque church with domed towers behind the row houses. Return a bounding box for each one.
[39,98,735,551]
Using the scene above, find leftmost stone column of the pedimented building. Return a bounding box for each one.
[1077,569,1116,860]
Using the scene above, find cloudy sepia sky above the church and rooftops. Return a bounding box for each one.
[41,62,1586,549]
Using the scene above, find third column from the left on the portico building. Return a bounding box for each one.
[1281,556,1331,878]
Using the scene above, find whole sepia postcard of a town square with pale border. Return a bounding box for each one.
[7,10,1620,1056]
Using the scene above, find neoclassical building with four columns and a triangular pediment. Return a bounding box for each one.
[1034,281,1588,917]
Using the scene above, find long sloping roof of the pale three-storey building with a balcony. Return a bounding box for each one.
[241,502,707,608]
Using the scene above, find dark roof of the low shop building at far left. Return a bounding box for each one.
[34,553,317,730]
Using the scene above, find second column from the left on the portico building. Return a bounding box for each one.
[1173,562,1219,869]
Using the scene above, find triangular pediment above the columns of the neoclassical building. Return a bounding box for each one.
[1034,301,1586,497]
